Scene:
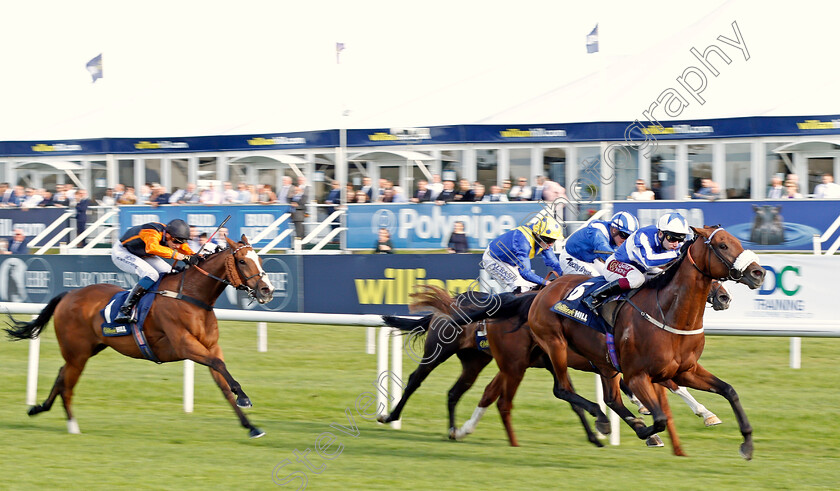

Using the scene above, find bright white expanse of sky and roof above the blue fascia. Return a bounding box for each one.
[0,0,840,140]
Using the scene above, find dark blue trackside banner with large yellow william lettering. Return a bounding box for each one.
[303,254,481,314]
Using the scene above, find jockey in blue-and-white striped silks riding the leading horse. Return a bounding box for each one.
[583,213,689,310]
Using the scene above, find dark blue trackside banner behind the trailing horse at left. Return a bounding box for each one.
[0,255,302,312]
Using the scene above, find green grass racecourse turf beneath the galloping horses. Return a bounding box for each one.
[0,322,840,490]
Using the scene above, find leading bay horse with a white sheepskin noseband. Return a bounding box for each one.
[528,226,765,460]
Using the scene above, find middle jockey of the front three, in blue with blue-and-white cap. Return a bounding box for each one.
[557,211,639,276]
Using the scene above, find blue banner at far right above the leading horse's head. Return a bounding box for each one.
[613,199,840,251]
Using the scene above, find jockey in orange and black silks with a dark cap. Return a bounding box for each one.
[111,219,198,324]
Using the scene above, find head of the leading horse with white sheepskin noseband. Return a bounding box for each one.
[689,225,765,290]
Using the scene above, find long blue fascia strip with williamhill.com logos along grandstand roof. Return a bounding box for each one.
[0,114,840,156]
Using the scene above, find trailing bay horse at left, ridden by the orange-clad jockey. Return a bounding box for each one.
[5,235,274,438]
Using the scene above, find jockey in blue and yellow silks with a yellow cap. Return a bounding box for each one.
[481,216,563,291]
